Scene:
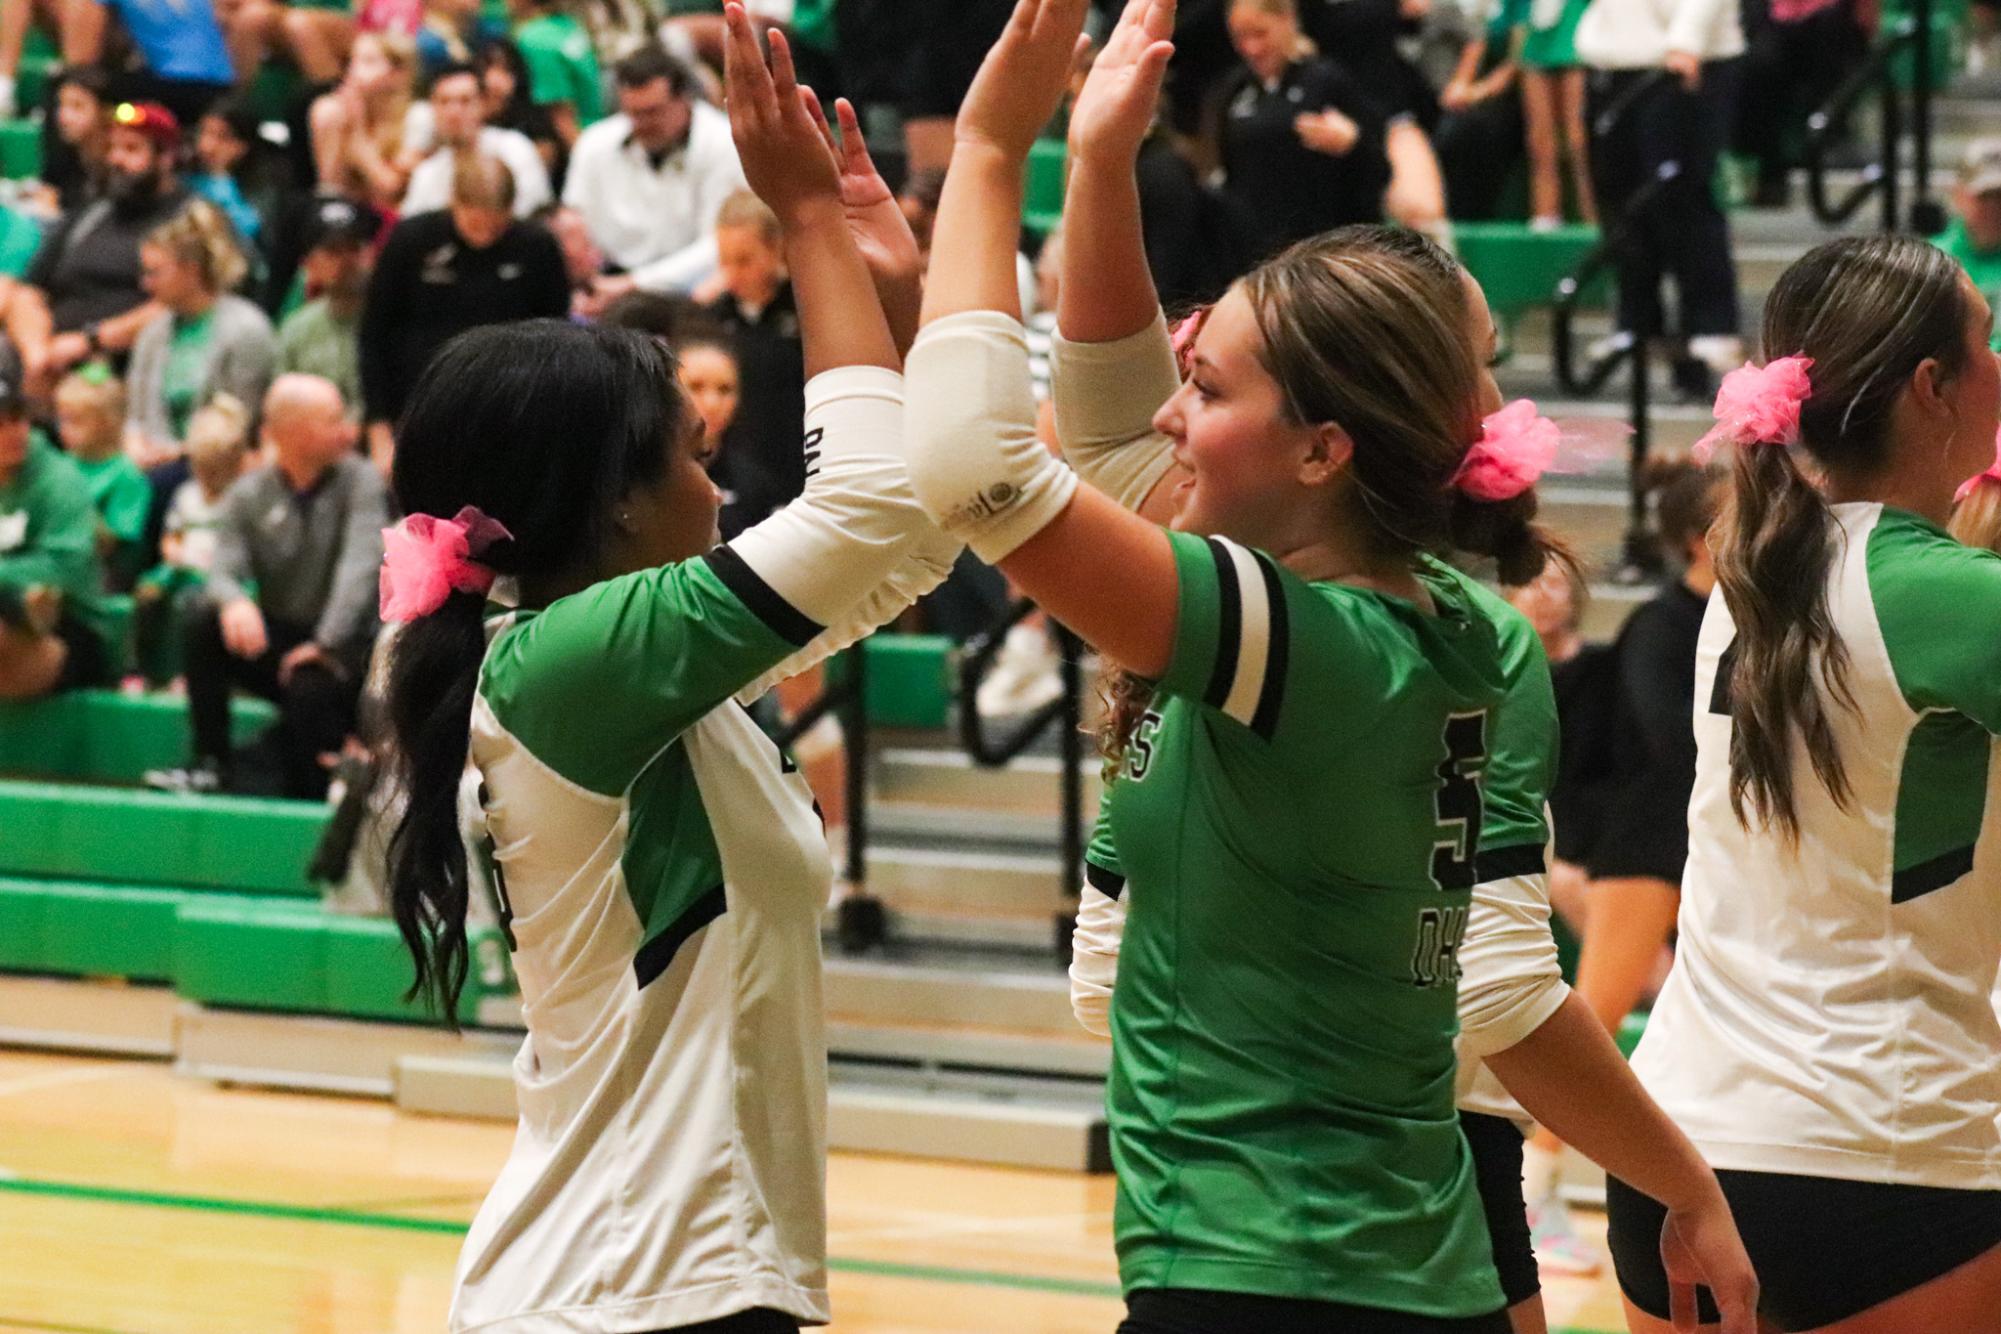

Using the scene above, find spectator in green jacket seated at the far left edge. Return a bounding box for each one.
[0,376,110,700]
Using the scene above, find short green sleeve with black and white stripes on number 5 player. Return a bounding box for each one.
[1161,532,1293,742]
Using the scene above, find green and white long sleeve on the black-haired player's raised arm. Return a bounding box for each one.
[482,366,934,794]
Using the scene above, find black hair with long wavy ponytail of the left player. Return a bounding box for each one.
[386,320,686,1026]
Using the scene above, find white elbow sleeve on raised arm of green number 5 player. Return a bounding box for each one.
[906,310,1077,564]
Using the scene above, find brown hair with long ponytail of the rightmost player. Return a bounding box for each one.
[1713,236,1967,842]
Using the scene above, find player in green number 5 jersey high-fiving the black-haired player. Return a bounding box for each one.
[908,0,1755,1332]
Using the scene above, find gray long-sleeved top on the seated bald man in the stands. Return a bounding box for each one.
[208,456,388,652]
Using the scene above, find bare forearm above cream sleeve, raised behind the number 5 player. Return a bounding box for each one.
[1057,154,1161,342]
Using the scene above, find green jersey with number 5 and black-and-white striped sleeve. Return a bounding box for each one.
[1093,534,1504,1316]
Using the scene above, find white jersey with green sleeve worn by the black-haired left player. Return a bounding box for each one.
[452,368,956,1334]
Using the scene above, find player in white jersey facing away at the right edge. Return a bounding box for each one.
[1611,236,2001,1334]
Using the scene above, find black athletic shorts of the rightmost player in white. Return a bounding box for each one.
[1605,1172,2001,1330]
